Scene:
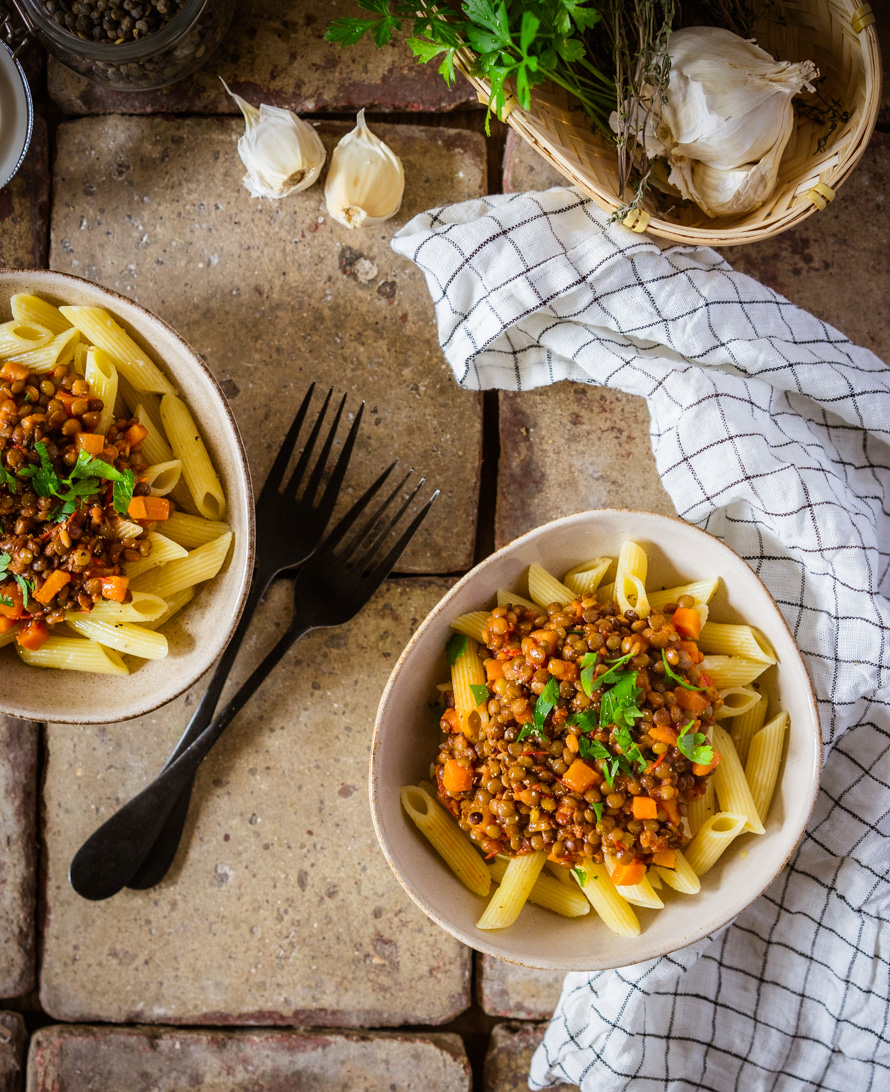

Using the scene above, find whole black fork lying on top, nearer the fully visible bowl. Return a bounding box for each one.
[70,464,439,899]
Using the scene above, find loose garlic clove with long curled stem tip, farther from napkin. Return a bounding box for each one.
[223,80,325,199]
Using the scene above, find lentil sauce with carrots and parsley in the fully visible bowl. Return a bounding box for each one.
[432,595,722,886]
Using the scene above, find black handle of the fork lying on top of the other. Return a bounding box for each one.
[68,617,316,900]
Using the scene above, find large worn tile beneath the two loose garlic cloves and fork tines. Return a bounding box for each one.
[50,118,485,572]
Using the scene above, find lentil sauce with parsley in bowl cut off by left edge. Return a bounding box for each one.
[0,360,161,650]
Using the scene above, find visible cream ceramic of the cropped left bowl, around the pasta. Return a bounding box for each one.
[0,270,256,724]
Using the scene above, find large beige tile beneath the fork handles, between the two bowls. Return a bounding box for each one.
[40,578,470,1026]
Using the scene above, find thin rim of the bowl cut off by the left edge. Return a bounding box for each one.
[0,268,257,724]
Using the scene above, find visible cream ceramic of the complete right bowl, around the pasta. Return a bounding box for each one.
[370,509,822,971]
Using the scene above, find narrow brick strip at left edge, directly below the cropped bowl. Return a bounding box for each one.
[0,715,39,997]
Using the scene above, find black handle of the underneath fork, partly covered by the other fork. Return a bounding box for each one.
[121,568,276,891]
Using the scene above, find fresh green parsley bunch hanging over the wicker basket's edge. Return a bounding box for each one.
[325,0,615,132]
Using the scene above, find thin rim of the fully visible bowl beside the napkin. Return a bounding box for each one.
[368,508,823,972]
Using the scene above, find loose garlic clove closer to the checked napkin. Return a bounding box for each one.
[324,110,405,227]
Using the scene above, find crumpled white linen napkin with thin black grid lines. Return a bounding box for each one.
[393,189,890,1092]
